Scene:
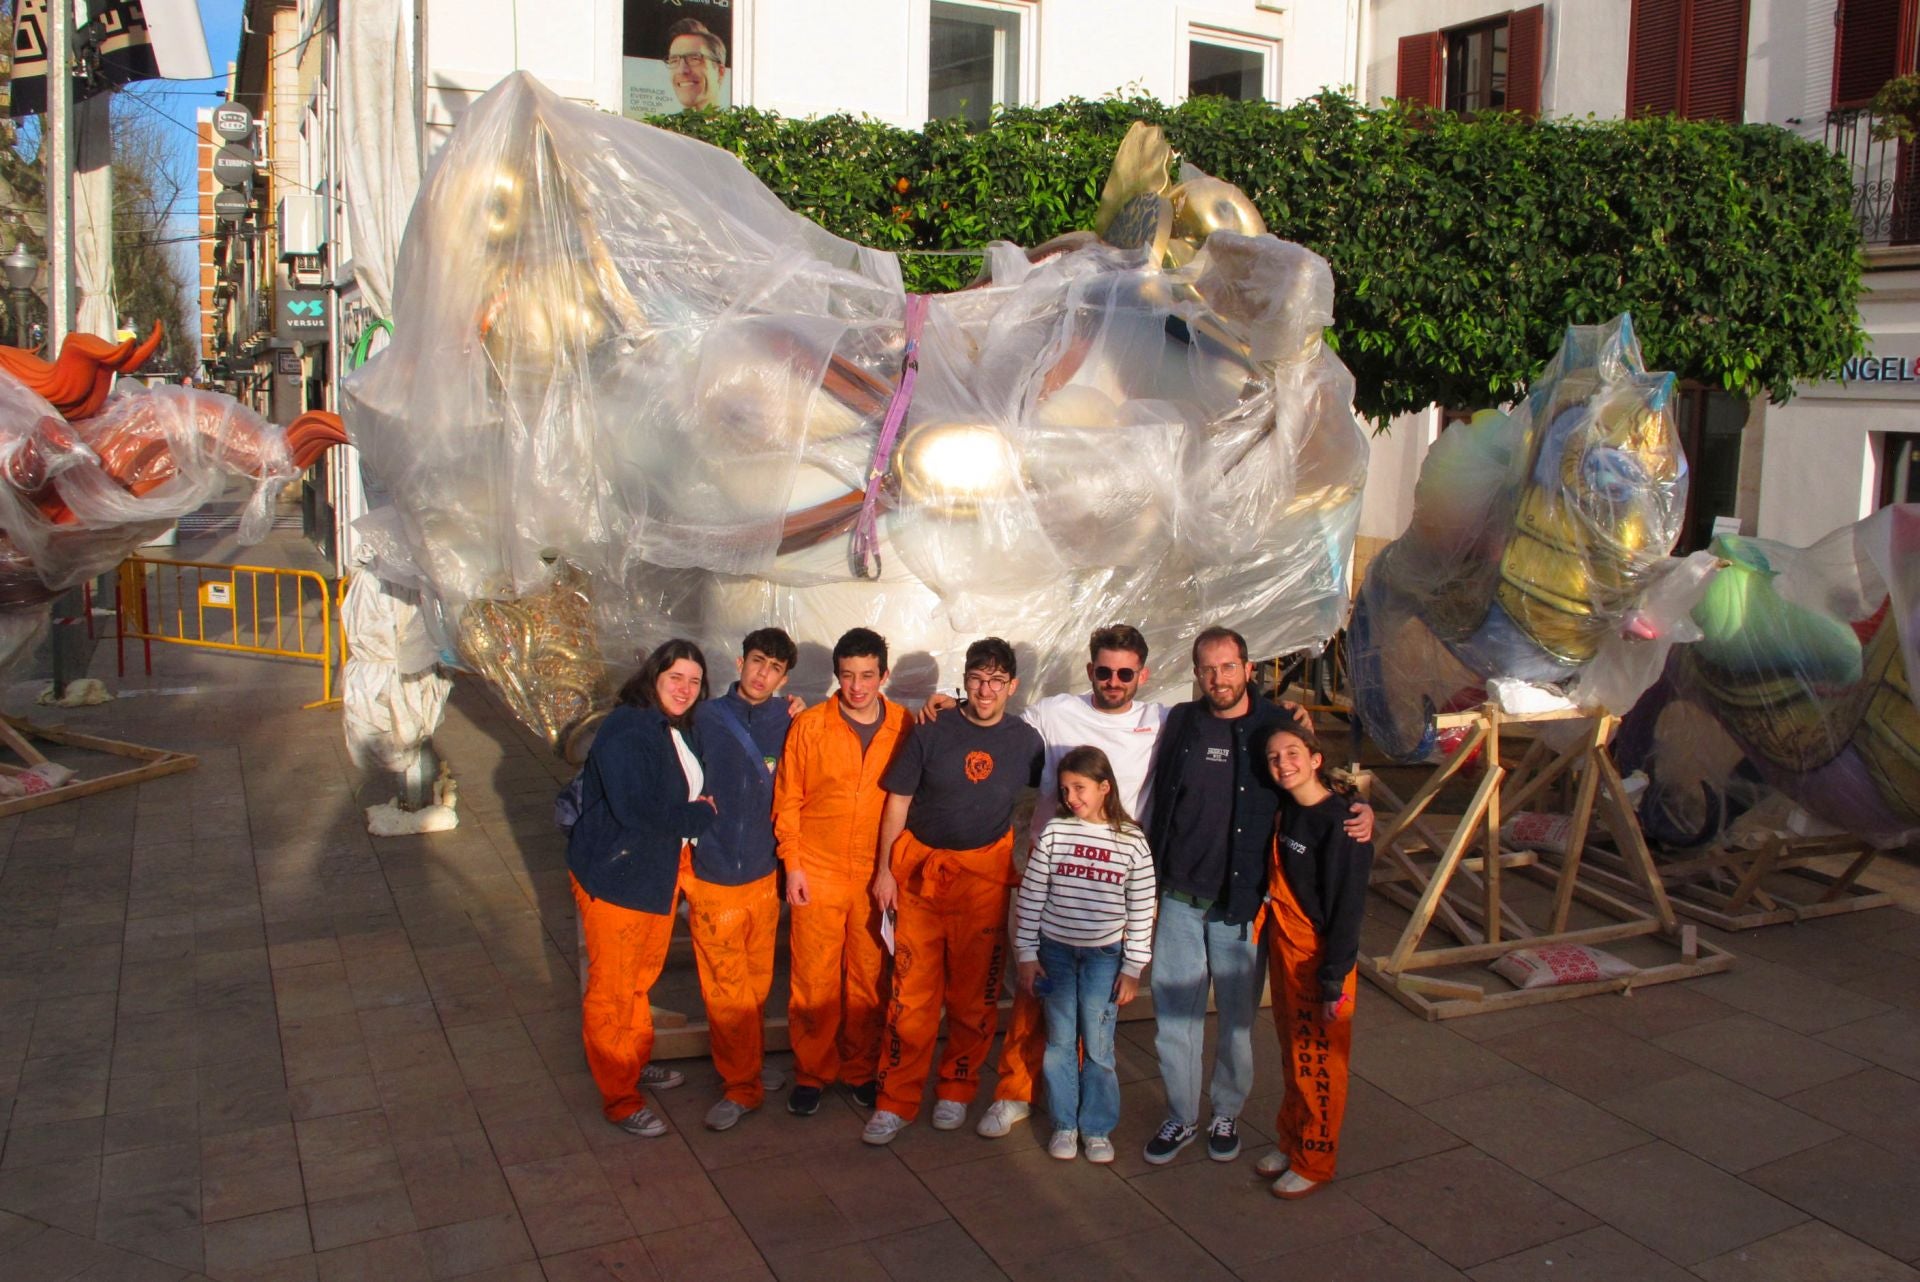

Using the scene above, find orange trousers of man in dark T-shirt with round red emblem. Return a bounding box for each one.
[879,833,1014,1121]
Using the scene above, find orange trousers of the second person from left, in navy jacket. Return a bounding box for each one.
[680,856,780,1109]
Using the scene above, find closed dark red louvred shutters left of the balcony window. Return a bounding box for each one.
[1626,0,1747,125]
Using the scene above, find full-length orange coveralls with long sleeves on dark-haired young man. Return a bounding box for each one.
[774,699,906,1086]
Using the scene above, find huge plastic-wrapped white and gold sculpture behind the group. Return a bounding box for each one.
[346,75,1367,743]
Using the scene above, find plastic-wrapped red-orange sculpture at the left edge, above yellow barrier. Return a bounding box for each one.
[0,326,346,672]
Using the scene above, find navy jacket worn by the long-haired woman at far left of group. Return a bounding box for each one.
[566,704,714,915]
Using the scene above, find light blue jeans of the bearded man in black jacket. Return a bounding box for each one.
[1154,894,1261,1127]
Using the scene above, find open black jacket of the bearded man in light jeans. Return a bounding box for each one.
[1146,689,1292,925]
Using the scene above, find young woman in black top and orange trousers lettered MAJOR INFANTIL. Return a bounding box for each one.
[1258,720,1373,1198]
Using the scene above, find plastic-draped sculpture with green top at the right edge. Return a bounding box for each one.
[1615,505,1920,846]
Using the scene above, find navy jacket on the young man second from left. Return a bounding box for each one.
[693,681,793,887]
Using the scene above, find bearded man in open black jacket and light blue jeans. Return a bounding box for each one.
[1144,628,1373,1165]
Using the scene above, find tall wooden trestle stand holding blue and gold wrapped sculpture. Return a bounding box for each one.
[1359,704,1734,1019]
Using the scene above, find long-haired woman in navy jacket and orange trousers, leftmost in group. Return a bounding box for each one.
[566,639,714,1136]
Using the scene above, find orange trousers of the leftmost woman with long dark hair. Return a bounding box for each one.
[568,854,687,1121]
